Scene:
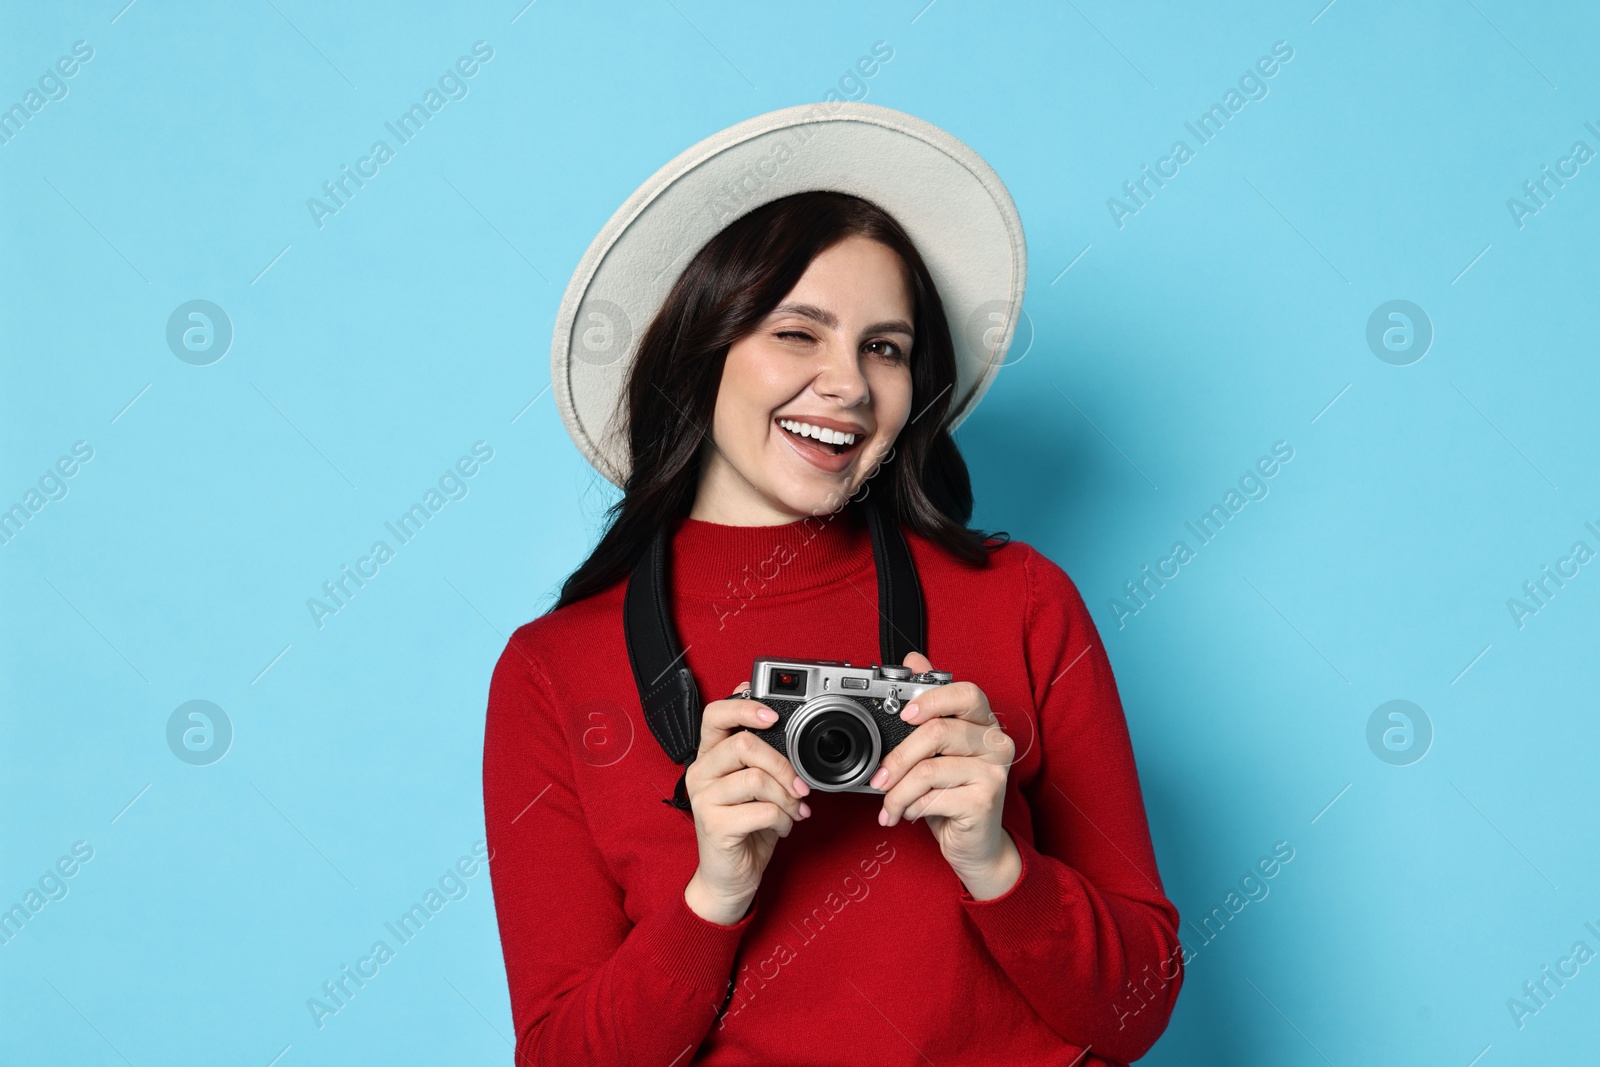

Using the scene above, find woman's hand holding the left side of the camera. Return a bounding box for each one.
[683,681,811,926]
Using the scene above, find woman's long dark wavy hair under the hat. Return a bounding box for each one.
[550,192,1008,611]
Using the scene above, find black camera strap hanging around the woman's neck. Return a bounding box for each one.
[622,501,928,811]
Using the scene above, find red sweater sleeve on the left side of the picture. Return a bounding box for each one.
[483,630,760,1067]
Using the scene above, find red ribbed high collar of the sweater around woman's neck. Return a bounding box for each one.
[672,507,872,600]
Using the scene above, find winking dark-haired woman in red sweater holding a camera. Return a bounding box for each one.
[483,109,1182,1067]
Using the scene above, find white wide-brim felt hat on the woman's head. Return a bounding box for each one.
[550,102,1027,486]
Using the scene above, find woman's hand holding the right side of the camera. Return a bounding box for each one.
[869,653,1022,901]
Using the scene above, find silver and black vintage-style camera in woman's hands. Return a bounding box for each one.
[746,659,952,795]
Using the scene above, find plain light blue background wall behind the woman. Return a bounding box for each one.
[0,0,1600,1067]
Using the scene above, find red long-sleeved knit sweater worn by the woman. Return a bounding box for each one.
[483,514,1182,1067]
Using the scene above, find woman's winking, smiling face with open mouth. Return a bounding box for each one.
[690,237,914,526]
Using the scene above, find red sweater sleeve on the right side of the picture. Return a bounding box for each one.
[960,547,1184,1062]
